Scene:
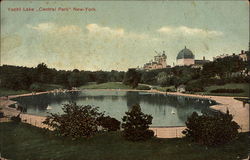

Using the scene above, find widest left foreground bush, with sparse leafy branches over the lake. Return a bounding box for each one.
[43,103,103,138]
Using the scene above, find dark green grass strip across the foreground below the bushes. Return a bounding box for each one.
[0,122,249,160]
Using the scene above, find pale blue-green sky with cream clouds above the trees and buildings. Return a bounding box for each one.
[1,0,249,71]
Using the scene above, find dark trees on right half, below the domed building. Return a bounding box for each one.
[124,56,250,92]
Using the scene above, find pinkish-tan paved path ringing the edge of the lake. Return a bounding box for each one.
[0,89,249,138]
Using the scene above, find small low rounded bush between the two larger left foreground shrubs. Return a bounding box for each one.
[97,116,121,131]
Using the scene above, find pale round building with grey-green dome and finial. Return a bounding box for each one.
[176,46,194,66]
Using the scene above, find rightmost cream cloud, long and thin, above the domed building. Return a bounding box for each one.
[157,26,223,37]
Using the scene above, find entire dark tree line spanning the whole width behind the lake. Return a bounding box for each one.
[0,56,250,92]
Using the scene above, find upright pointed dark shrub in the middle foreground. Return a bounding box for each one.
[122,105,154,141]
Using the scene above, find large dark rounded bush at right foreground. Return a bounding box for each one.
[182,111,240,145]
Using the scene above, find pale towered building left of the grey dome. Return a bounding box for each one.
[143,51,168,70]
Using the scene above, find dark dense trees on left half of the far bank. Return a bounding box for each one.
[0,63,125,91]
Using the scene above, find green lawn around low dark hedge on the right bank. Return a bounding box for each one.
[204,83,250,97]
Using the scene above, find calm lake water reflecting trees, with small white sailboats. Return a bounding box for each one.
[15,90,215,126]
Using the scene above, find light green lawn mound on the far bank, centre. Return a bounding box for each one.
[79,82,132,89]
